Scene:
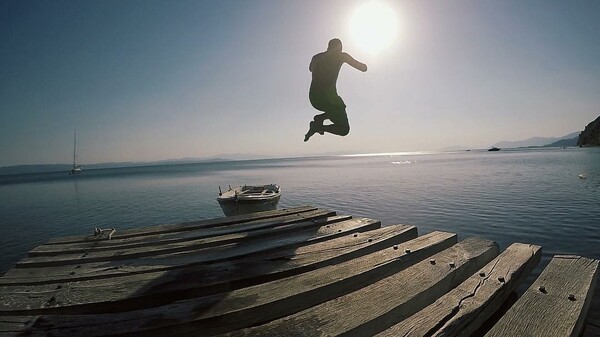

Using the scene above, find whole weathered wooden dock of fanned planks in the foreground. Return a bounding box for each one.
[0,206,599,337]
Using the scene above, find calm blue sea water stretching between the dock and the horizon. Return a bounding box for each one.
[0,148,600,284]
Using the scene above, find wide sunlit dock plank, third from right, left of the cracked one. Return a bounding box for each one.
[219,238,498,336]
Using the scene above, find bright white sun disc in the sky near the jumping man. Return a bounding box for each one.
[350,0,398,54]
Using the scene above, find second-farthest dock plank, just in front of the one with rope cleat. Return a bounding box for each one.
[28,209,338,260]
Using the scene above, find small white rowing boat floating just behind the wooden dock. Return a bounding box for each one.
[217,184,281,216]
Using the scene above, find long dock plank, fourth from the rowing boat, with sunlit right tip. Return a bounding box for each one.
[0,217,381,285]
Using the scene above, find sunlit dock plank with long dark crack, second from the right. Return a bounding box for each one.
[377,243,542,337]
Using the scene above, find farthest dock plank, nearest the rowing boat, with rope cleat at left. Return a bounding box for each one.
[46,206,317,244]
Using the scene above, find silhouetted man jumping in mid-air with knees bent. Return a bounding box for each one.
[304,39,367,142]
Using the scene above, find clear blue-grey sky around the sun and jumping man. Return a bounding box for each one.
[0,0,600,166]
